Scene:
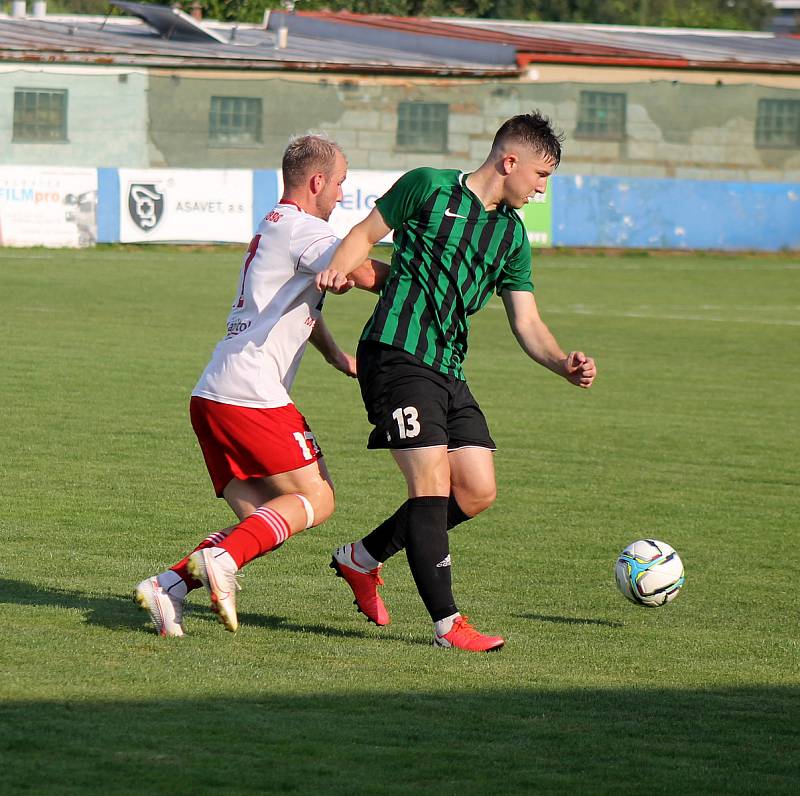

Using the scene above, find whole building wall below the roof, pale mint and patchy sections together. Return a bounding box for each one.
[0,66,800,182]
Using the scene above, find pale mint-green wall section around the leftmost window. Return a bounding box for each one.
[0,65,148,167]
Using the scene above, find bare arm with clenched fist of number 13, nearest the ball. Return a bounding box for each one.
[501,290,597,389]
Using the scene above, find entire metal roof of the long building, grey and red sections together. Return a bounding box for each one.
[0,2,800,77]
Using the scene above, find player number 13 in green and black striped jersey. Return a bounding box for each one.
[317,113,596,651]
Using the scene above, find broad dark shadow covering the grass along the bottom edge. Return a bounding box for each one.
[0,684,800,796]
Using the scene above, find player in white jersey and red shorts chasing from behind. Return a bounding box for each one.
[134,135,384,636]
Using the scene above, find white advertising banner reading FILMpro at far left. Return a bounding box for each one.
[0,166,97,247]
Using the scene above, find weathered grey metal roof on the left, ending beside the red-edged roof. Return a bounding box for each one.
[0,3,519,76]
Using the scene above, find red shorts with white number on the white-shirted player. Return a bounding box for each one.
[189,395,322,497]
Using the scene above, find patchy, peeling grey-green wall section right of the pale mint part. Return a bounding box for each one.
[144,68,800,182]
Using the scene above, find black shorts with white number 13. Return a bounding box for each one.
[357,341,497,450]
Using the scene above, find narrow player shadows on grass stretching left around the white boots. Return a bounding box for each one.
[0,578,376,643]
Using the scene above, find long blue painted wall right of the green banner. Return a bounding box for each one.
[553,175,800,251]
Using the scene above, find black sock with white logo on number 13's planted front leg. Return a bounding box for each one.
[406,497,458,622]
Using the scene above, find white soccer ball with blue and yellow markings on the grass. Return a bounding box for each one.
[614,539,686,608]
